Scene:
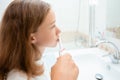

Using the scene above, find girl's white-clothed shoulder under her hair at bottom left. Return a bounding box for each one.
[7,70,28,80]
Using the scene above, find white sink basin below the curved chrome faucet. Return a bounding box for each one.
[73,53,120,80]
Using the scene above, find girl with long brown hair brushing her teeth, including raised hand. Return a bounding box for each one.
[0,0,79,80]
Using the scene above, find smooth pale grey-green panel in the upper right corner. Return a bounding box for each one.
[106,0,120,27]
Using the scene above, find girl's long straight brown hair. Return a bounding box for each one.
[0,0,50,79]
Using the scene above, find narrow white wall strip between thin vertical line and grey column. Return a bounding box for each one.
[78,0,89,35]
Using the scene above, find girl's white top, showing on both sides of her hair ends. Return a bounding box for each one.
[7,60,50,80]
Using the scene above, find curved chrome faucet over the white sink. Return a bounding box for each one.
[95,40,120,64]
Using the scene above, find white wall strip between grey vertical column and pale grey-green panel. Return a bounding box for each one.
[95,0,107,36]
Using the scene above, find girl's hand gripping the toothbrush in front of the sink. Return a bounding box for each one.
[51,54,79,80]
